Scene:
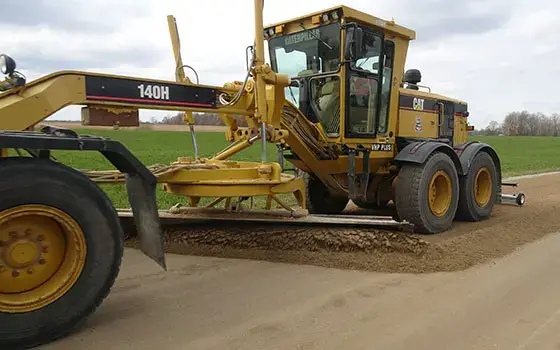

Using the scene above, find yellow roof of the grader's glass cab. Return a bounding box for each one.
[265,5,416,40]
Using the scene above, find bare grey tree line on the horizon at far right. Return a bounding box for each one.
[470,111,560,136]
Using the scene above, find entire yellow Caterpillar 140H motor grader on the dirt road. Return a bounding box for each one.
[0,0,524,349]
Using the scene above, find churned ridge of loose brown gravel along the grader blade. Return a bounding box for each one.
[127,174,560,273]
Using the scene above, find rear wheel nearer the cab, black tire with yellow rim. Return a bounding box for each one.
[395,152,459,234]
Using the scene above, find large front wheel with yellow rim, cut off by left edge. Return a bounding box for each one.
[0,158,123,349]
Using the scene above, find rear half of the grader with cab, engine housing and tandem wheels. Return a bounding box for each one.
[264,6,523,233]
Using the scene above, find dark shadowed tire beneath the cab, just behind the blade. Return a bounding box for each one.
[304,174,349,215]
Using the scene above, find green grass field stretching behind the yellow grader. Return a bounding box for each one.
[41,130,560,208]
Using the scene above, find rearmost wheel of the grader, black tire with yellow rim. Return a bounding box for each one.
[457,152,498,221]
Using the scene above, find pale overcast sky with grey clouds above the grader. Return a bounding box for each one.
[0,0,560,128]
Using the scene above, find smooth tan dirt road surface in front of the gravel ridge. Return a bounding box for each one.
[43,230,560,350]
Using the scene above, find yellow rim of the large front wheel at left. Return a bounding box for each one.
[0,205,86,313]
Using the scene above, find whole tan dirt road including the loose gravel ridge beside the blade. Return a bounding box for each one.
[36,175,560,350]
